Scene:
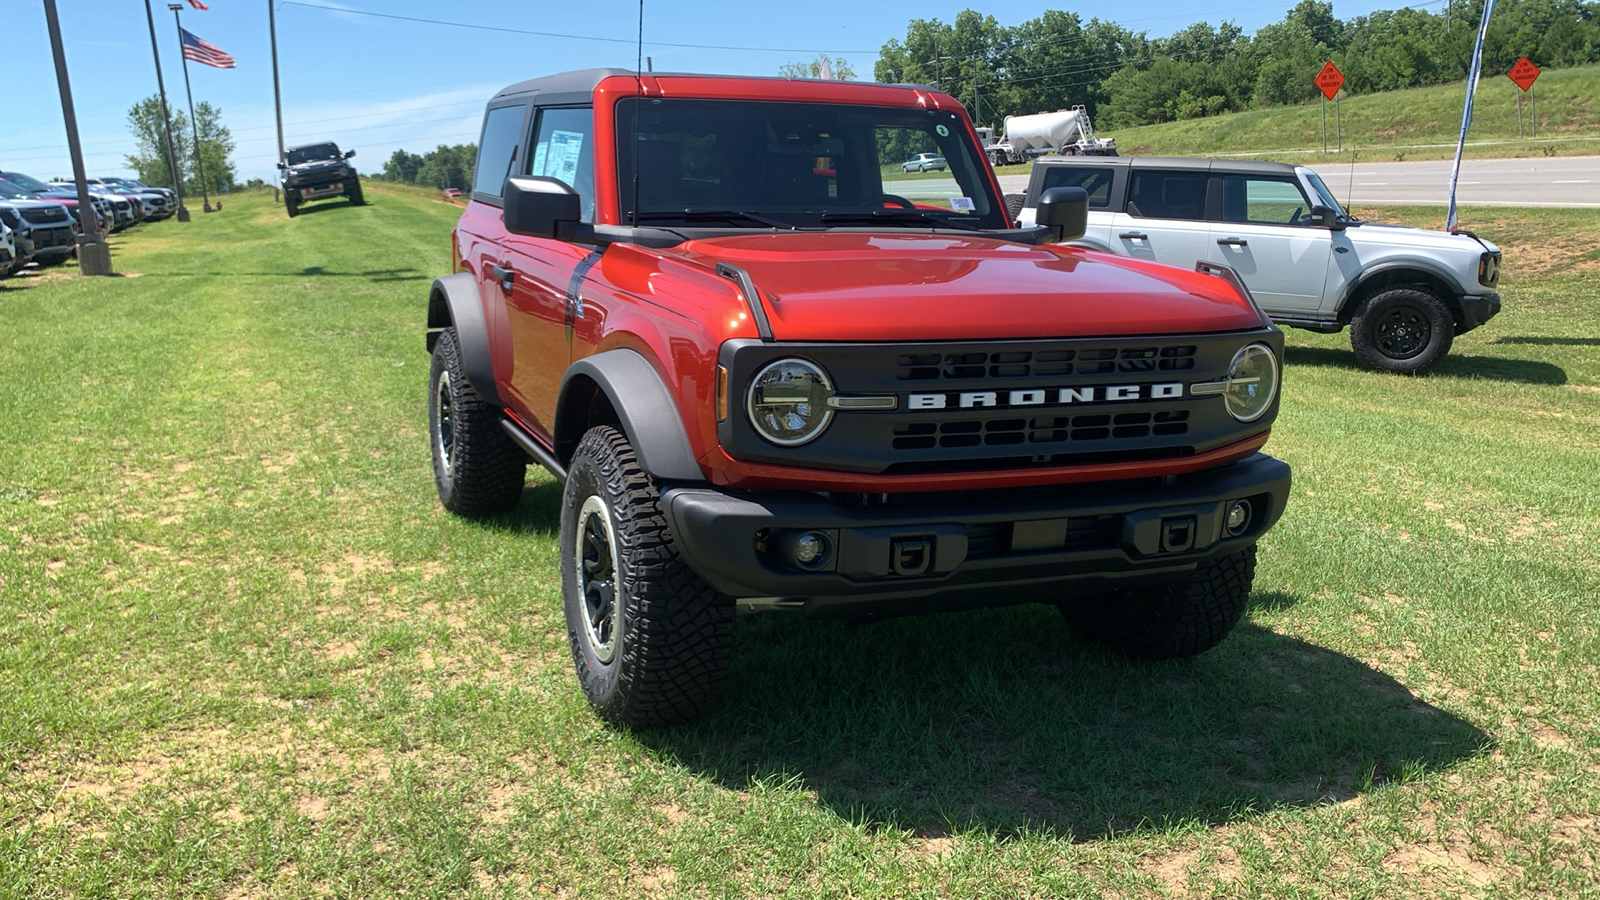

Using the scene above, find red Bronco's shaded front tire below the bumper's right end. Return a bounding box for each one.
[1061,546,1256,660]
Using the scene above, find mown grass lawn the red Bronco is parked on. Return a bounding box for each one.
[0,184,1600,898]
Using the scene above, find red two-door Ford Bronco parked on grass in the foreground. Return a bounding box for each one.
[427,70,1290,727]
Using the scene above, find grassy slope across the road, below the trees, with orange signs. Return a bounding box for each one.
[1000,66,1600,173]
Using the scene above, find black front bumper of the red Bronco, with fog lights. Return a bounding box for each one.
[661,453,1290,612]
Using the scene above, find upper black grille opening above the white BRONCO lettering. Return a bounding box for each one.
[894,344,1197,374]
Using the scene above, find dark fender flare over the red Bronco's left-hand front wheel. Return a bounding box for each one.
[555,349,706,482]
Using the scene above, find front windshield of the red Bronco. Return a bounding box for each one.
[618,99,1010,229]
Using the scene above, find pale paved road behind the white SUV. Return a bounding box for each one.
[1000,157,1600,208]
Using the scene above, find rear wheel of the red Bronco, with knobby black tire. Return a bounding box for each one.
[427,328,528,517]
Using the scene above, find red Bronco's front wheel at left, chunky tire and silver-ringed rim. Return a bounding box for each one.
[562,426,734,729]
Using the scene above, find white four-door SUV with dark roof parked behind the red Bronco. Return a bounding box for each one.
[1019,157,1501,373]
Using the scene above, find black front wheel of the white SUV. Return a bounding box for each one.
[1350,285,1456,375]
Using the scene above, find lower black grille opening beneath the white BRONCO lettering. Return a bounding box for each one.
[893,410,1189,450]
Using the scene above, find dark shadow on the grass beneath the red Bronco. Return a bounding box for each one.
[640,597,1490,841]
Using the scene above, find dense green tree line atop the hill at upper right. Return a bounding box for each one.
[874,0,1600,128]
